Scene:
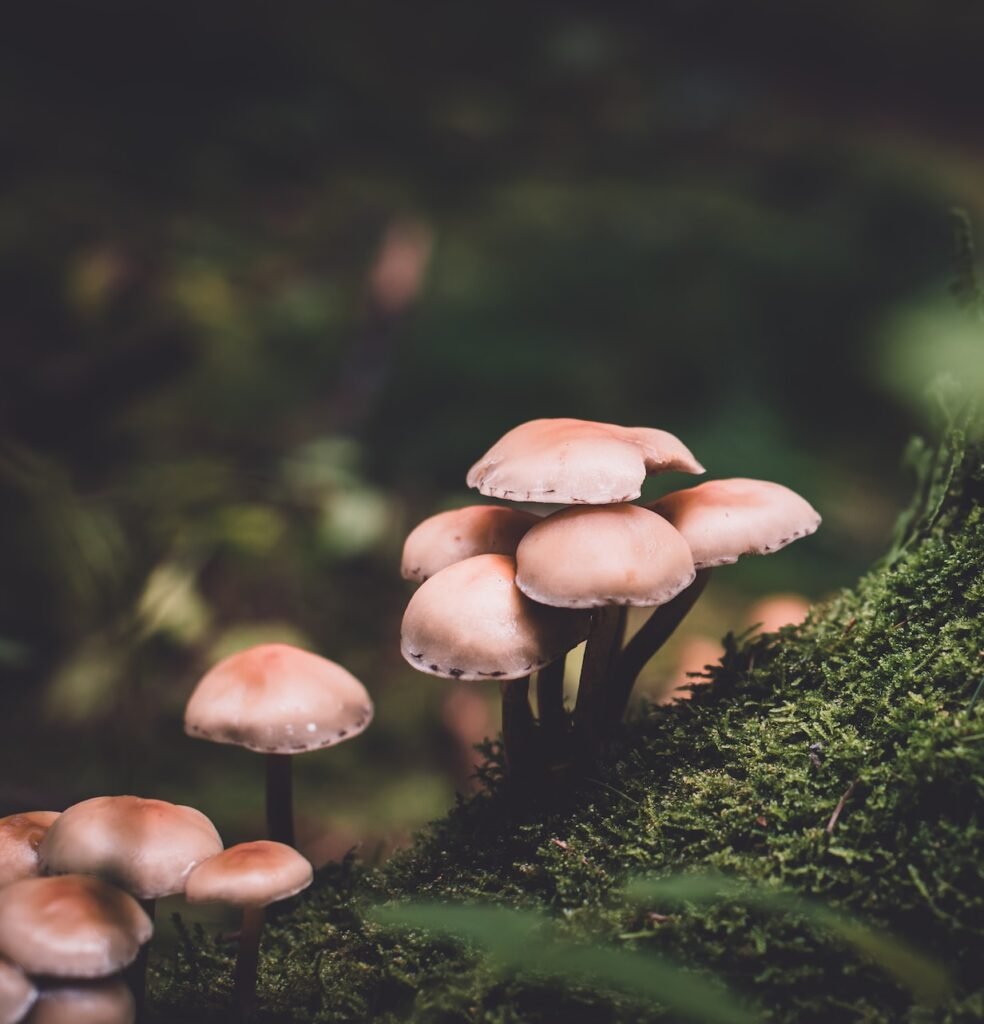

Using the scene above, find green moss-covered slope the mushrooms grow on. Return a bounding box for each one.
[154,423,984,1024]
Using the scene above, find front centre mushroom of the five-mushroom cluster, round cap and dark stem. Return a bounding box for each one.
[516,504,694,754]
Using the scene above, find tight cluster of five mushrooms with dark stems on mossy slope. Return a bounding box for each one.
[401,419,820,780]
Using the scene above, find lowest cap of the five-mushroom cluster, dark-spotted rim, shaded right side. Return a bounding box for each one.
[400,555,591,680]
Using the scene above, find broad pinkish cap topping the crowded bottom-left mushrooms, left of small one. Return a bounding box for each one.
[38,797,222,899]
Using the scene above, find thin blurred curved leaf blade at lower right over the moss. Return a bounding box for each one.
[628,874,950,1002]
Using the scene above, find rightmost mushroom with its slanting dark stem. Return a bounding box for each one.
[608,478,820,722]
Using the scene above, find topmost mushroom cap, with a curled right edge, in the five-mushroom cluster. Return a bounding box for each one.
[468,419,703,505]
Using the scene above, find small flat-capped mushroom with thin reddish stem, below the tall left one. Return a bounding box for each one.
[185,840,313,1021]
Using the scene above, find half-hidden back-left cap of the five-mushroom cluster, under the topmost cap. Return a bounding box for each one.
[400,505,539,583]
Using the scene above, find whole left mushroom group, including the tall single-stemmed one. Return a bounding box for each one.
[0,644,373,1024]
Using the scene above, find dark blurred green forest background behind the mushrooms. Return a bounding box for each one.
[0,0,984,901]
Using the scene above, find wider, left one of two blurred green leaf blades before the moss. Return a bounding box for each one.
[370,903,759,1024]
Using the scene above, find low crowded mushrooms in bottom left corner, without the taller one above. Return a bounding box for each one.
[0,796,312,1024]
